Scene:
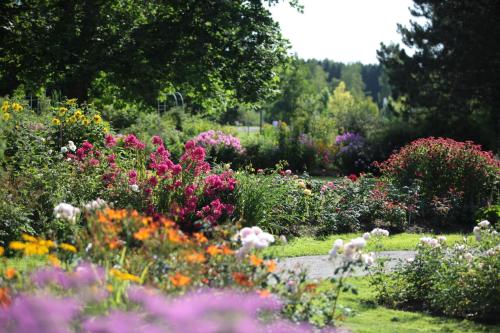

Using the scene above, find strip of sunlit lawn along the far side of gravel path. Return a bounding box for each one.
[264,233,473,257]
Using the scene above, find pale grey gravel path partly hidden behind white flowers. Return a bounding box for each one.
[278,251,415,279]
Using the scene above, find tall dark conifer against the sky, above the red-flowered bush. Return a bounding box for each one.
[378,0,500,150]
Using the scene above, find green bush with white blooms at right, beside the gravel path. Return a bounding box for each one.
[373,221,500,322]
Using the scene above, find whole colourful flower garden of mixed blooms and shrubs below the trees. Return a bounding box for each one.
[0,99,500,333]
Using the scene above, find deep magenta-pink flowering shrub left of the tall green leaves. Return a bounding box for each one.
[67,134,236,231]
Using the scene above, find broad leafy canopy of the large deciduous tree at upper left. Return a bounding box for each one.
[0,0,294,109]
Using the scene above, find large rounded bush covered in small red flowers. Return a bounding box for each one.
[378,137,500,224]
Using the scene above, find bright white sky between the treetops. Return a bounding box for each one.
[271,0,412,64]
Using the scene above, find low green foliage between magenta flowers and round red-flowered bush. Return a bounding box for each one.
[236,170,417,235]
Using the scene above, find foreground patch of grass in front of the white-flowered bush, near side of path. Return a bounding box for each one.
[332,277,500,333]
